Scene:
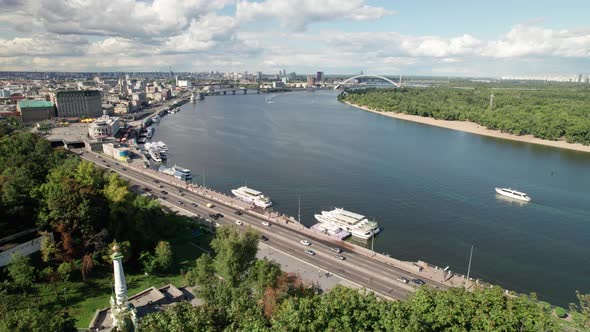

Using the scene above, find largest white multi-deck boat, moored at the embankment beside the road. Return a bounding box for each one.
[315,208,381,240]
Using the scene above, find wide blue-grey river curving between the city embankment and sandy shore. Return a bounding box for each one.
[153,91,590,306]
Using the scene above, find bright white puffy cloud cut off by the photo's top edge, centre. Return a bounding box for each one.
[236,0,394,31]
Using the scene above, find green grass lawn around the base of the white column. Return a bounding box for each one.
[34,233,212,328]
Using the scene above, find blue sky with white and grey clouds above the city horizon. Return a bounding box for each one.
[0,0,590,77]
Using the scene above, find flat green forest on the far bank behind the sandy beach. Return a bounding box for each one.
[339,85,590,145]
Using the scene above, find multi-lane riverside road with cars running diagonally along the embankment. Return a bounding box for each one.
[80,152,446,299]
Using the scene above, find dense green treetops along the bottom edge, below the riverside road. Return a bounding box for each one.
[140,227,590,332]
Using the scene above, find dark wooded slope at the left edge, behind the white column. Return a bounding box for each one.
[0,124,195,331]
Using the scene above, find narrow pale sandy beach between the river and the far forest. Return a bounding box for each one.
[345,101,590,152]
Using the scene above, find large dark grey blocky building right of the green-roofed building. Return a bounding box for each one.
[54,90,102,118]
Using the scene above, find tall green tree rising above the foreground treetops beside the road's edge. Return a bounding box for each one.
[211,227,259,285]
